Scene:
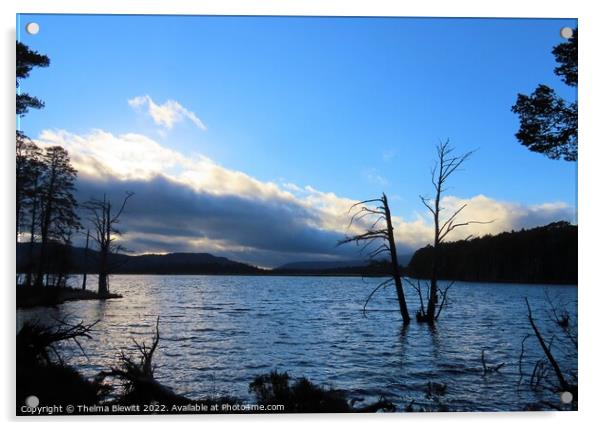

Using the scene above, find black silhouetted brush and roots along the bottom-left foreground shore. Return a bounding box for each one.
[16,319,395,415]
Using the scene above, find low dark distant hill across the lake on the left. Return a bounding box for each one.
[17,243,265,274]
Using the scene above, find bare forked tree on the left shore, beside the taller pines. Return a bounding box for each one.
[84,192,134,296]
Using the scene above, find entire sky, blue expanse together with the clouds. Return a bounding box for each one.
[17,15,577,267]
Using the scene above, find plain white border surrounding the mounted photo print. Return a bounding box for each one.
[0,0,602,430]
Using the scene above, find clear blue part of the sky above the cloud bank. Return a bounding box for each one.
[18,15,577,264]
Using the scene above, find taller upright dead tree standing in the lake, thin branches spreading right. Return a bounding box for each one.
[416,140,492,324]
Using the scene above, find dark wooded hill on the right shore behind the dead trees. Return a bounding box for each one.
[407,221,577,284]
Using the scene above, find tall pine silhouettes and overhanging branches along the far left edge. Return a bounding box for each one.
[15,42,81,287]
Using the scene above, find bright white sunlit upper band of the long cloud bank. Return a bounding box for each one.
[36,130,574,255]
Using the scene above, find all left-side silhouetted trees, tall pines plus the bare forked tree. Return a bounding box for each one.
[15,42,132,295]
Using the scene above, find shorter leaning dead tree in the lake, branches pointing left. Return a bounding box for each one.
[338,193,411,324]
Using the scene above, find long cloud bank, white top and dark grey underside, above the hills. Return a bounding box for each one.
[37,130,574,267]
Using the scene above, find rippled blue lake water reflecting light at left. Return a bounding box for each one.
[17,275,577,410]
